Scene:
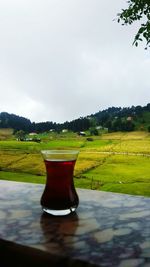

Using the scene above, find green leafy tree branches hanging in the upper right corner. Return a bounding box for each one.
[118,0,150,49]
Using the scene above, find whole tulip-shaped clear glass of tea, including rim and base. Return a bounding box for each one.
[41,150,79,216]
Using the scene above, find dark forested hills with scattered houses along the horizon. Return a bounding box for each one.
[0,104,150,134]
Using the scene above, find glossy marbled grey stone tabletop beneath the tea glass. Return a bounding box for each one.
[0,180,150,267]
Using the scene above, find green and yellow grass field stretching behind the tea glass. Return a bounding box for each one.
[0,131,150,196]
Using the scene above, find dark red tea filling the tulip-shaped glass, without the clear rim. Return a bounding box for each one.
[41,160,79,213]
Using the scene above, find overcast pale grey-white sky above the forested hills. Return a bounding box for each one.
[0,0,150,122]
